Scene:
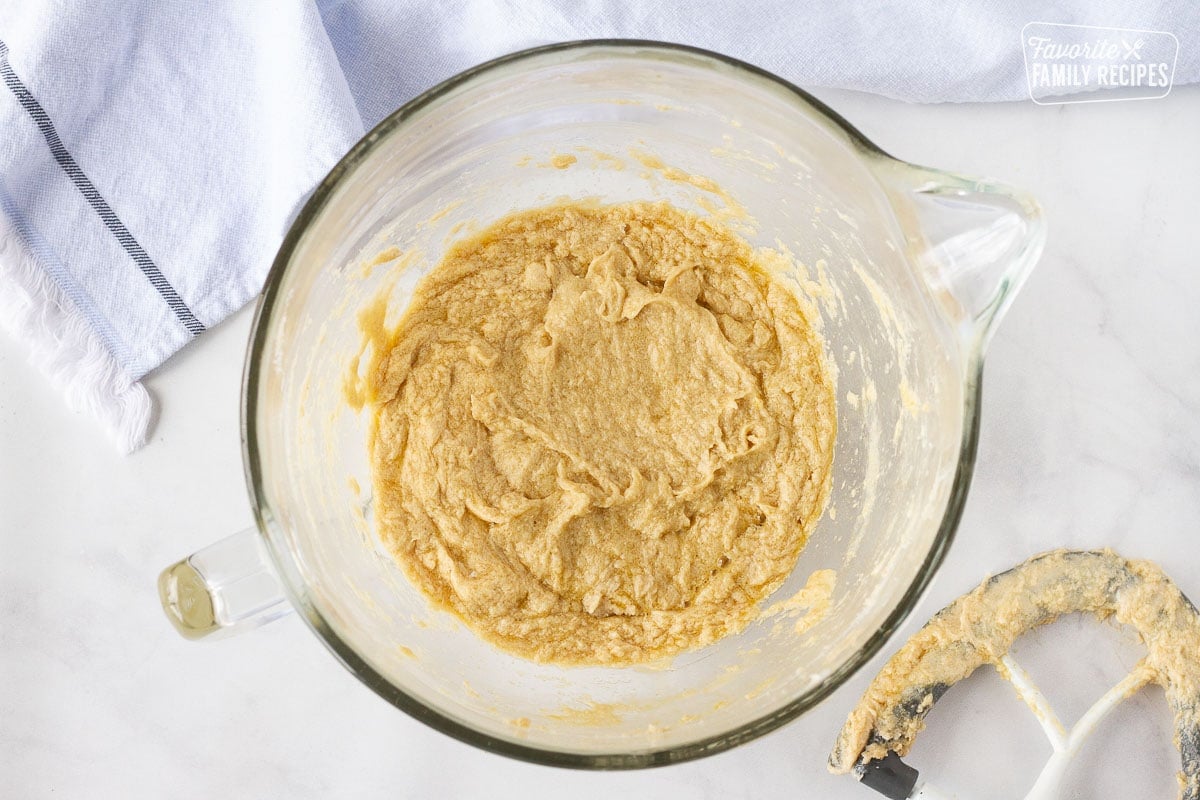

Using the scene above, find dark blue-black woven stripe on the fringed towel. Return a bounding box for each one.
[0,41,204,336]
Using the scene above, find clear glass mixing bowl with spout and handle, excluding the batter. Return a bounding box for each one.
[160,41,1044,768]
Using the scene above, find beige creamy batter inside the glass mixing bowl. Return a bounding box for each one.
[366,204,835,664]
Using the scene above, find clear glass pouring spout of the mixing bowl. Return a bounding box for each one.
[875,158,1046,354]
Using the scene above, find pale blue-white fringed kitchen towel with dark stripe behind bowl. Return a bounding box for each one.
[0,0,1200,451]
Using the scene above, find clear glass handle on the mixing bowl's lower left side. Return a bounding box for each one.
[158,528,292,639]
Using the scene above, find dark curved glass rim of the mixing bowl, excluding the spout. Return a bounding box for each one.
[241,38,982,770]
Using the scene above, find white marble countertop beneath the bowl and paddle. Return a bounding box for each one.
[0,89,1200,800]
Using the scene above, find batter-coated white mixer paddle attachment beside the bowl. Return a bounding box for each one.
[829,551,1200,800]
